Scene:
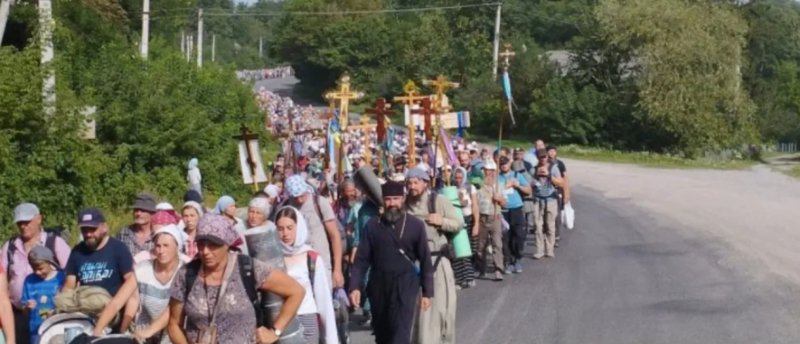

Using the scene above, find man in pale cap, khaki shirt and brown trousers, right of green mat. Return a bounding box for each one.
[476,160,506,281]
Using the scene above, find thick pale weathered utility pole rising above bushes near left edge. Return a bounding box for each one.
[39,0,56,117]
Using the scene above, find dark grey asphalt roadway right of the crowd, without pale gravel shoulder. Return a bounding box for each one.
[260,78,800,344]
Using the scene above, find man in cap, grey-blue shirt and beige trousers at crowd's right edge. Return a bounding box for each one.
[533,149,564,259]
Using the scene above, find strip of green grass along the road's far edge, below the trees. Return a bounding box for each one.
[471,137,756,173]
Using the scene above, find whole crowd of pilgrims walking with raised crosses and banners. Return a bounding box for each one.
[0,47,574,344]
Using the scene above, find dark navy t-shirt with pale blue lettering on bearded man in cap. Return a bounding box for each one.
[64,237,133,296]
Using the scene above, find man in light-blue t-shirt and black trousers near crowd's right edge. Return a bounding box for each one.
[497,156,531,274]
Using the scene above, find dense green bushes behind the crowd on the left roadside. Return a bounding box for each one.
[0,41,266,238]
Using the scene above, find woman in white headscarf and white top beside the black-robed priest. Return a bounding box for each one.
[275,207,339,344]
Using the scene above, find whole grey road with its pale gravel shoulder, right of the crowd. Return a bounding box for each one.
[260,77,800,344]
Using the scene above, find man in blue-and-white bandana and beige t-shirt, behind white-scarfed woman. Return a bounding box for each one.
[278,175,344,287]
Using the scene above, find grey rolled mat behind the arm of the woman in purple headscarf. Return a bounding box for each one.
[244,226,305,344]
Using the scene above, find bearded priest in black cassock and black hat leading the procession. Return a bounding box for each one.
[350,181,433,344]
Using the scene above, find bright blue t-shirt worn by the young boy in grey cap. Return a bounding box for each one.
[21,271,64,343]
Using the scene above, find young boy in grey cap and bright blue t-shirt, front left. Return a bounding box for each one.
[22,246,64,343]
